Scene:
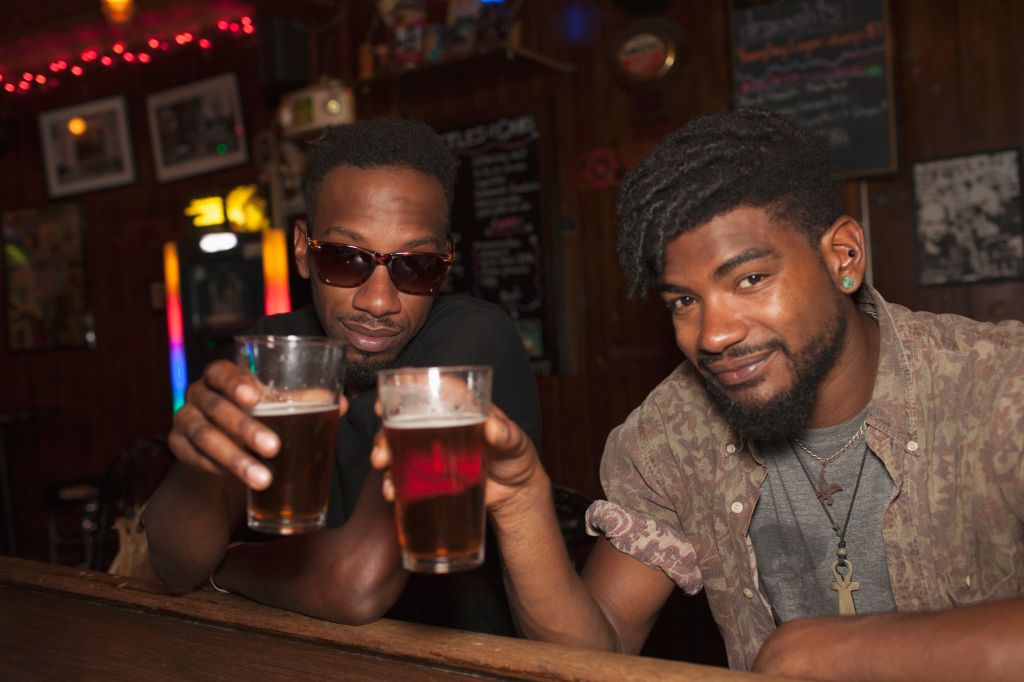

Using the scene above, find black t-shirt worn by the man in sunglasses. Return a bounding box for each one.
[253,295,541,635]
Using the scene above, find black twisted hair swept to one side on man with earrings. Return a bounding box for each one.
[616,110,842,297]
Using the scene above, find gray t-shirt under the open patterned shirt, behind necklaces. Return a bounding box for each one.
[750,409,896,624]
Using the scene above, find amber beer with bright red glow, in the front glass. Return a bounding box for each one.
[384,415,486,573]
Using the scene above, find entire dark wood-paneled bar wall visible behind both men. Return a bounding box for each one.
[0,0,1024,556]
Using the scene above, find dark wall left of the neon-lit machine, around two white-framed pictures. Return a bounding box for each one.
[0,40,270,558]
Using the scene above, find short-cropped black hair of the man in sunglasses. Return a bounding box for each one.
[305,117,459,230]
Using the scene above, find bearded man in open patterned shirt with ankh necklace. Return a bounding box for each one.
[374,111,1024,680]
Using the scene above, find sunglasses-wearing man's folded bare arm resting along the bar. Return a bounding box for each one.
[214,474,409,625]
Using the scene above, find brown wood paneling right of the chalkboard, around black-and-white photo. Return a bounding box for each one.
[866,0,1024,322]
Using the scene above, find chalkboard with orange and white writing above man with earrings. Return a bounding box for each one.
[732,0,896,177]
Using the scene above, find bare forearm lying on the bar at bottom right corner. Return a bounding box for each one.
[755,599,1024,681]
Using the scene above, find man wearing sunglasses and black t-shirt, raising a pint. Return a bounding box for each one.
[145,119,541,635]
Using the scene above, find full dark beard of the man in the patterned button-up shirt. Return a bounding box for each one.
[698,292,848,441]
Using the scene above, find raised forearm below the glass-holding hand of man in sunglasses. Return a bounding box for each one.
[145,463,245,592]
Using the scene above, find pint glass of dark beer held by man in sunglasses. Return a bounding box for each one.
[236,336,345,536]
